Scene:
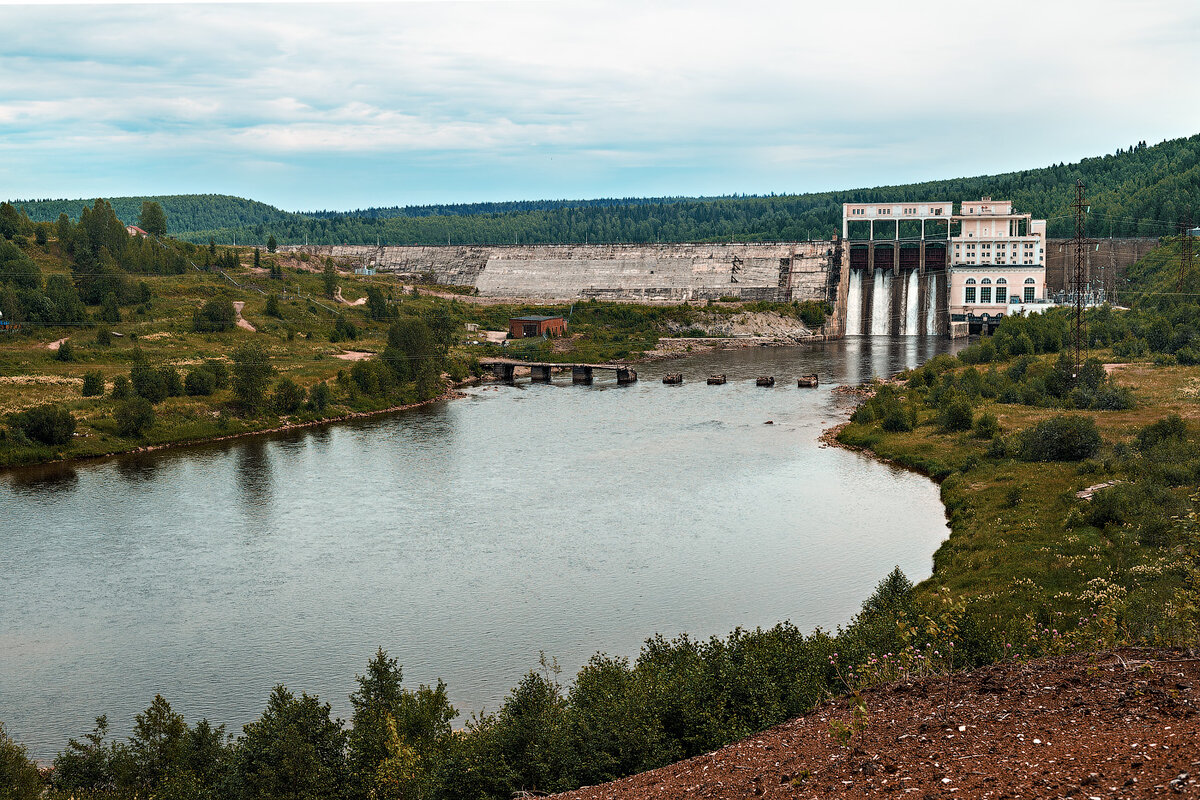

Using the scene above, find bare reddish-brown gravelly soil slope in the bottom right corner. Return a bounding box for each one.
[556,650,1200,800]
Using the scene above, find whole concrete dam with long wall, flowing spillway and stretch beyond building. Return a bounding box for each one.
[280,239,1156,336]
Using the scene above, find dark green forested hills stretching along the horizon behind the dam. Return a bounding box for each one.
[14,134,1200,245]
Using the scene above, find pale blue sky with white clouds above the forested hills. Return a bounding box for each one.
[0,0,1200,211]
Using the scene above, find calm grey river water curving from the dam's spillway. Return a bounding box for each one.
[0,338,950,760]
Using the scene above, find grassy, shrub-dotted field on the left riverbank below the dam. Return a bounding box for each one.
[0,239,821,467]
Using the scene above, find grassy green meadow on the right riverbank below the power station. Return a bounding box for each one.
[839,351,1200,640]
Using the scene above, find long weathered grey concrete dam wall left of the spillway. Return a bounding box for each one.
[280,241,838,302]
